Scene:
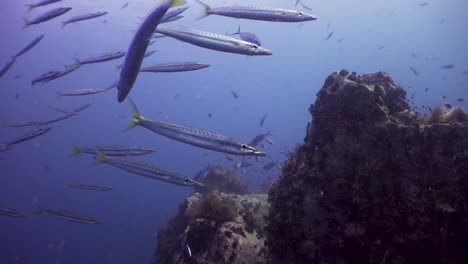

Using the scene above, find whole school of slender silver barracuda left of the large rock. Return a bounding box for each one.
[0,0,317,224]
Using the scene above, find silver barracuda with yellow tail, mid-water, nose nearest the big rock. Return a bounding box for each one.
[129,99,266,156]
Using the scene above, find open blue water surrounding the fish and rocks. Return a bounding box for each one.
[0,0,468,264]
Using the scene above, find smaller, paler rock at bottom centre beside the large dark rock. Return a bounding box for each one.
[156,192,269,264]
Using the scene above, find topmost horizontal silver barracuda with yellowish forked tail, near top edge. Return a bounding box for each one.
[196,0,317,22]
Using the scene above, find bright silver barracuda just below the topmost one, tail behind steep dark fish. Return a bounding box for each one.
[156,26,272,55]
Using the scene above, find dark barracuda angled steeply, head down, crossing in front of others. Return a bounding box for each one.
[117,0,185,103]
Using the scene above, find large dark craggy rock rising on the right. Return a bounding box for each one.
[266,70,468,264]
